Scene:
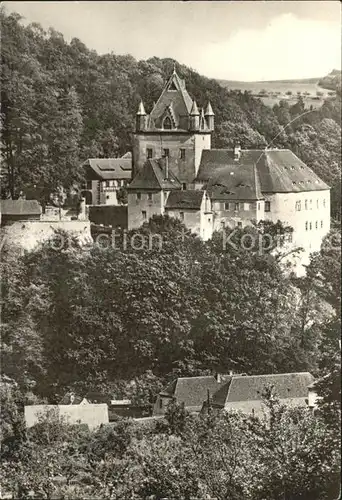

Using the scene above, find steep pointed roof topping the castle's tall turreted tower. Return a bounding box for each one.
[150,71,192,127]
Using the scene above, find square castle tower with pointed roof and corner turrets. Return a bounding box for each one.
[133,68,214,184]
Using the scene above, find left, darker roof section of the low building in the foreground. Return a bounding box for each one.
[160,375,221,408]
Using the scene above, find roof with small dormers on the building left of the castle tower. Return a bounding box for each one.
[83,155,132,180]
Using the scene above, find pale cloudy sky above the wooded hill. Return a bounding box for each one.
[3,0,341,81]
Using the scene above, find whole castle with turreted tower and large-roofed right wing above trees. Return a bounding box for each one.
[128,69,330,252]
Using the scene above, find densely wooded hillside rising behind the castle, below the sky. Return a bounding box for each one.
[1,12,341,217]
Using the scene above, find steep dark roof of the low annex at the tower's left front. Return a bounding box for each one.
[128,160,181,191]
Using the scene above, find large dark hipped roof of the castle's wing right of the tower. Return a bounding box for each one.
[196,149,329,193]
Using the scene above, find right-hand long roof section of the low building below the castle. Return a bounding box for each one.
[212,372,314,406]
